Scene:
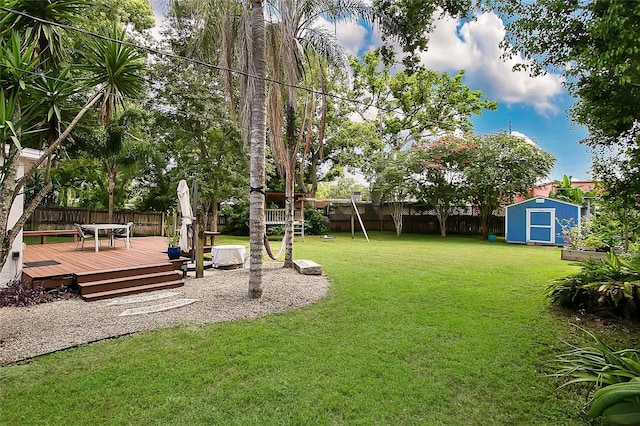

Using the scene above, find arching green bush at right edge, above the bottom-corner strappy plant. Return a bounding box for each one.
[546,251,640,318]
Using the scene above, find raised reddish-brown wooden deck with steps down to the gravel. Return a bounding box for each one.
[22,237,187,300]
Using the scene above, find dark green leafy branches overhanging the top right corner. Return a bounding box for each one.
[497,0,640,146]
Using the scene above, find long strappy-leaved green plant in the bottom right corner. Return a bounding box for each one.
[554,330,640,424]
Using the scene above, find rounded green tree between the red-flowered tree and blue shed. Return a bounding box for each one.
[464,132,555,240]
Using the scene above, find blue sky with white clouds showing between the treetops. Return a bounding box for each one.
[150,0,591,180]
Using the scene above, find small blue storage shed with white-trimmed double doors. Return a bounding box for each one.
[505,197,581,245]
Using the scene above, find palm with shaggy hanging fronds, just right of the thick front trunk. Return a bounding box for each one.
[267,0,368,268]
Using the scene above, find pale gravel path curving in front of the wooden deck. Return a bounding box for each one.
[0,263,329,365]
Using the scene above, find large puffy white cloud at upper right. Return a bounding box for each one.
[421,12,562,116]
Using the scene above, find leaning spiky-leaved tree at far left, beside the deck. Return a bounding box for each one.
[0,5,142,265]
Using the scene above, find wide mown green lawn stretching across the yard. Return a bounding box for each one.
[0,233,624,425]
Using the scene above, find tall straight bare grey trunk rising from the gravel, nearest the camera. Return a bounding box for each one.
[248,0,267,299]
